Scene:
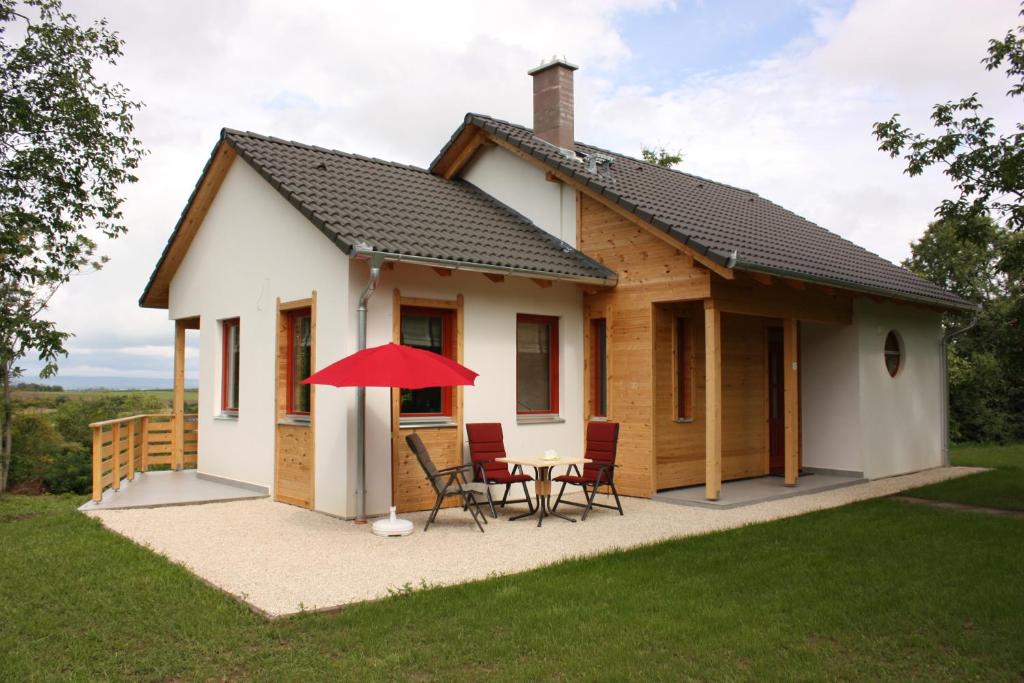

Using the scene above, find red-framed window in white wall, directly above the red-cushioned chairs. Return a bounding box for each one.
[516,314,558,415]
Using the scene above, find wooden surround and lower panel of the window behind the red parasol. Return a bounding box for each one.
[391,290,464,512]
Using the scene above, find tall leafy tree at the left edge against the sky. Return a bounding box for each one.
[0,0,143,493]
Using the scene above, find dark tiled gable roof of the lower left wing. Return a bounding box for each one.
[139,128,616,307]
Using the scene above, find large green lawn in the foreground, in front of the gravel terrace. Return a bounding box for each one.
[0,448,1024,681]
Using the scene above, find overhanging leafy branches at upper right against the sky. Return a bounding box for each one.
[874,4,1024,259]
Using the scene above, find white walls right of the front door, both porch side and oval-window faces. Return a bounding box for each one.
[801,299,944,479]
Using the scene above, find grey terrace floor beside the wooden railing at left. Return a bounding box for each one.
[79,470,267,512]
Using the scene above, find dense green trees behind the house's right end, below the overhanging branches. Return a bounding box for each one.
[903,216,1024,441]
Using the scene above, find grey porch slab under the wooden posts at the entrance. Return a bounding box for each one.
[654,472,865,510]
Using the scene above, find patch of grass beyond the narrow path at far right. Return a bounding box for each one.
[906,443,1024,510]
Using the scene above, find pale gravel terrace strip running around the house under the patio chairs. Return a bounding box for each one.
[81,467,984,616]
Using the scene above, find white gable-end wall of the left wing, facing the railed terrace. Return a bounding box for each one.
[169,159,355,514]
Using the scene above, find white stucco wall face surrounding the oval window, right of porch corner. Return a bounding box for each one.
[854,300,943,479]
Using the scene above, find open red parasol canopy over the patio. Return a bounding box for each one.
[302,343,477,389]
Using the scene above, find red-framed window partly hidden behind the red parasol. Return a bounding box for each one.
[399,306,455,418]
